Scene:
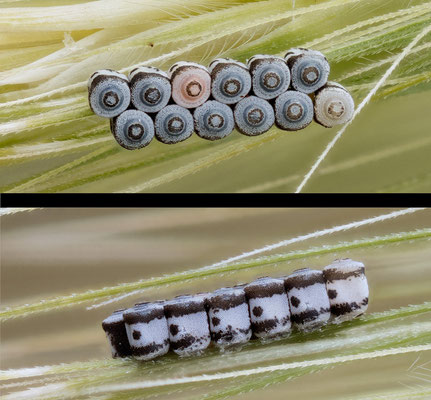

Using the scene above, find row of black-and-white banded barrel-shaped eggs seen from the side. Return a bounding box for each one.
[102,259,368,360]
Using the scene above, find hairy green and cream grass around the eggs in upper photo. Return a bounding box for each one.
[0,0,431,192]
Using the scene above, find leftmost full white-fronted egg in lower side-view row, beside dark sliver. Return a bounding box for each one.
[123,302,169,360]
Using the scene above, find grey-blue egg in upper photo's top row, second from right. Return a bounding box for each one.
[247,54,290,100]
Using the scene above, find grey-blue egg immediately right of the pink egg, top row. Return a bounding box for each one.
[209,58,251,104]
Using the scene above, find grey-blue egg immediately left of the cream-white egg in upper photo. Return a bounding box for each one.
[274,90,314,131]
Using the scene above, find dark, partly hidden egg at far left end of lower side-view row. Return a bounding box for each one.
[102,309,132,358]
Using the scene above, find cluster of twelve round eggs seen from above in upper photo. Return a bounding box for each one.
[88,48,354,150]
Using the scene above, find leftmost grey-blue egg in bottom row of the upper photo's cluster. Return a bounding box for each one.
[111,110,154,150]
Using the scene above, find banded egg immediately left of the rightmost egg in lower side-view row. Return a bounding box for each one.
[284,268,331,331]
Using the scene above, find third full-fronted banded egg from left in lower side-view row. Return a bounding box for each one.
[207,287,252,348]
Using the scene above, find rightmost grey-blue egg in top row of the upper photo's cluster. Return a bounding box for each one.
[284,48,330,94]
